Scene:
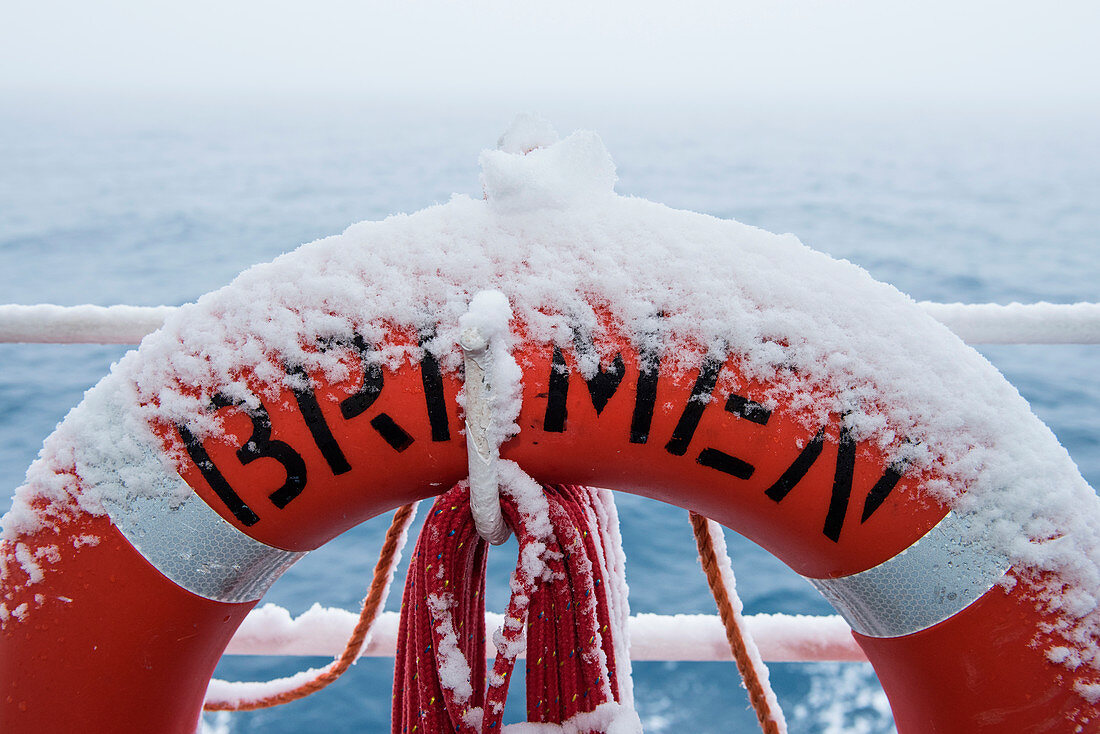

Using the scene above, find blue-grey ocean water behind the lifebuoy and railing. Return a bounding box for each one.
[0,100,1100,734]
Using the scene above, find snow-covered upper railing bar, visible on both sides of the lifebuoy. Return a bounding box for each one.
[0,302,1100,344]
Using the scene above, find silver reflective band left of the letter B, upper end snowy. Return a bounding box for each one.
[76,385,306,603]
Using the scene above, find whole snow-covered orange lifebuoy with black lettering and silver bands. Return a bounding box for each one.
[0,123,1100,734]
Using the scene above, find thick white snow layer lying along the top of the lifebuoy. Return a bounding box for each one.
[3,119,1100,669]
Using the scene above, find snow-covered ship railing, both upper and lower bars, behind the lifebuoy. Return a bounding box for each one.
[0,302,1100,662]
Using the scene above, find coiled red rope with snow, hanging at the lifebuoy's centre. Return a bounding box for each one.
[393,484,635,734]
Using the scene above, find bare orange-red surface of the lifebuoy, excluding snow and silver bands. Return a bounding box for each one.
[0,312,1084,734]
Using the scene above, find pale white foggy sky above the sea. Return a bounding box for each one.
[0,0,1100,107]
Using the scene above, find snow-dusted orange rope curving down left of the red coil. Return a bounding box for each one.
[202,503,416,711]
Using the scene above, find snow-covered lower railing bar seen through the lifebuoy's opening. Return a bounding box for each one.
[226,604,867,662]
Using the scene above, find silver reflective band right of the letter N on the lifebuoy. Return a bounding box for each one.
[807,512,1011,637]
